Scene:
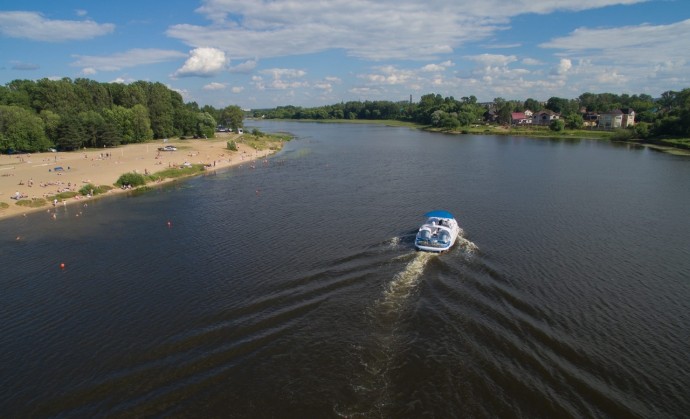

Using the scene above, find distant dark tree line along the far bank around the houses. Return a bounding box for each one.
[254,89,690,139]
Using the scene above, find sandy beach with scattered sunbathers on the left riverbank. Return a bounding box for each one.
[0,133,280,219]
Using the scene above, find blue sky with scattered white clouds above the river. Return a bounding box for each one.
[0,0,690,108]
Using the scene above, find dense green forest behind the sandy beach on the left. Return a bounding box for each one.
[0,78,244,152]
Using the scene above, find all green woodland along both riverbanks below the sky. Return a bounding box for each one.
[0,78,690,152]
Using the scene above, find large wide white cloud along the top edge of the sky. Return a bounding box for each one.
[167,0,647,61]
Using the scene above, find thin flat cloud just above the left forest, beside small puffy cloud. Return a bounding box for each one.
[71,49,186,74]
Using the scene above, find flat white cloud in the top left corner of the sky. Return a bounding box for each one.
[0,11,115,42]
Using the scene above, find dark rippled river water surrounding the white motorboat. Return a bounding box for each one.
[0,122,690,418]
